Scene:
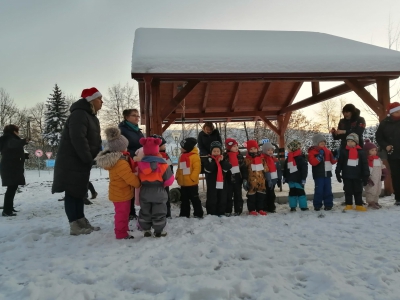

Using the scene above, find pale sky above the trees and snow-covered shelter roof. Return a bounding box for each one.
[0,0,400,111]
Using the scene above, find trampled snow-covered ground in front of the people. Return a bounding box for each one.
[0,169,400,300]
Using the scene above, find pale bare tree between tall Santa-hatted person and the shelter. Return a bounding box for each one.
[100,83,139,126]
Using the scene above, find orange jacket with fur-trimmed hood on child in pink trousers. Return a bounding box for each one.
[96,150,140,202]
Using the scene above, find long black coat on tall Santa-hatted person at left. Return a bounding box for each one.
[51,99,101,198]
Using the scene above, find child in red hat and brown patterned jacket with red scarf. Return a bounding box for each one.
[243,140,268,216]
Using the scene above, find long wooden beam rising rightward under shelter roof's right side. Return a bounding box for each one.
[279,81,375,115]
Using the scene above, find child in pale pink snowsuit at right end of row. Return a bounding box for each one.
[363,139,387,209]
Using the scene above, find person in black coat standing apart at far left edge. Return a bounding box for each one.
[0,124,28,217]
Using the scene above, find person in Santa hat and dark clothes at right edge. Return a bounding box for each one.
[376,102,400,205]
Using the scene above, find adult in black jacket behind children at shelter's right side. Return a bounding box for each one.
[331,104,365,149]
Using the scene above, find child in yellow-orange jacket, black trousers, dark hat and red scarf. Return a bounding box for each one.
[176,137,204,218]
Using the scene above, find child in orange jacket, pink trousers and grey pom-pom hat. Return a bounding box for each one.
[95,127,140,239]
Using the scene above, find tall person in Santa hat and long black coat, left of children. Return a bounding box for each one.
[52,87,103,235]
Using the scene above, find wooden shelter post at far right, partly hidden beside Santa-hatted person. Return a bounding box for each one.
[376,78,394,196]
